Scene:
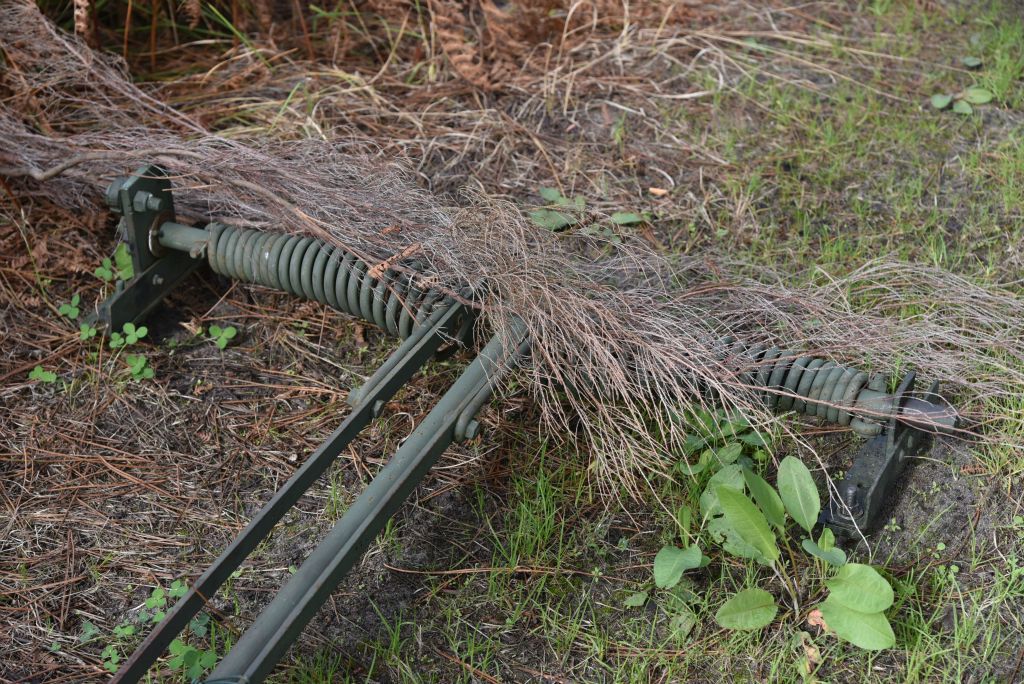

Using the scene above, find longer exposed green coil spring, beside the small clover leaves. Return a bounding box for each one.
[207,223,444,339]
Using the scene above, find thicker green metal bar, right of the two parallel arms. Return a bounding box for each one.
[209,321,521,684]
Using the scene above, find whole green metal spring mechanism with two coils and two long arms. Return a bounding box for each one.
[96,166,957,684]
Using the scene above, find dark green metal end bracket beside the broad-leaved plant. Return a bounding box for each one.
[821,373,938,537]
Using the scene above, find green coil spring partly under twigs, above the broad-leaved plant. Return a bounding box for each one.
[716,337,885,433]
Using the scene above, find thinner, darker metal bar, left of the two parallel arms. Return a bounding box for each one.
[112,303,465,684]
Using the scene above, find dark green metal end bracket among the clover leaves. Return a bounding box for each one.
[96,166,203,331]
